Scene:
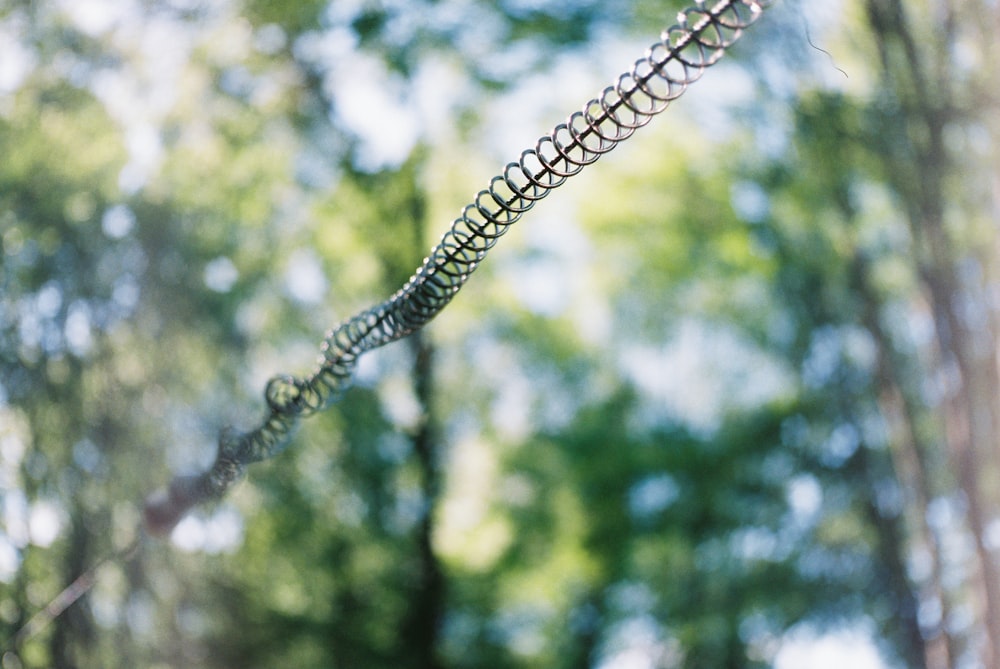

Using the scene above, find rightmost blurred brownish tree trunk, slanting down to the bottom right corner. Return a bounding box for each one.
[866,0,1000,667]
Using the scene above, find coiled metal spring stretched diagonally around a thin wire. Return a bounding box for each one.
[144,0,773,535]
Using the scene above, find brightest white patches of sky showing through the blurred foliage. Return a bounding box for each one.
[0,0,900,669]
